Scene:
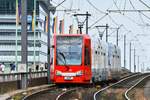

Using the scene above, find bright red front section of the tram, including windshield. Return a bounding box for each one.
[50,34,92,84]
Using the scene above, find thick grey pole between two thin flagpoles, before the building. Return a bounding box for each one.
[21,0,28,89]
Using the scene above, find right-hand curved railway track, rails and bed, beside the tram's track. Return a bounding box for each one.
[94,74,149,100]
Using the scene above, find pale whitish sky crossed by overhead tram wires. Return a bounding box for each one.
[51,0,150,71]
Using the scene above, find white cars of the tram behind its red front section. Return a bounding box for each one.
[92,40,121,82]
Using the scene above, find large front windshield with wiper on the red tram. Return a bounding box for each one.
[56,36,82,65]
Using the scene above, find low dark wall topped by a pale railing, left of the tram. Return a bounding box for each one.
[0,72,48,94]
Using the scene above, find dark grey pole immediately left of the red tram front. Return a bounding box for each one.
[47,12,51,83]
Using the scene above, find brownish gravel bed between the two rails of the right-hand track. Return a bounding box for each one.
[96,75,149,100]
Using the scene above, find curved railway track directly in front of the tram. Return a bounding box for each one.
[23,72,135,100]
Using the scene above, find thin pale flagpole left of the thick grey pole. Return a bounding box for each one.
[15,0,19,71]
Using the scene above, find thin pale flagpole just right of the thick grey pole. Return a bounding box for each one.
[33,0,36,69]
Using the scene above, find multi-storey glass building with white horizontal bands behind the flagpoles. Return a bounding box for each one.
[0,0,51,70]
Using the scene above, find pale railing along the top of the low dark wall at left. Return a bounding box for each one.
[0,71,47,83]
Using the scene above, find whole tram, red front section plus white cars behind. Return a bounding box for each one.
[50,34,121,84]
